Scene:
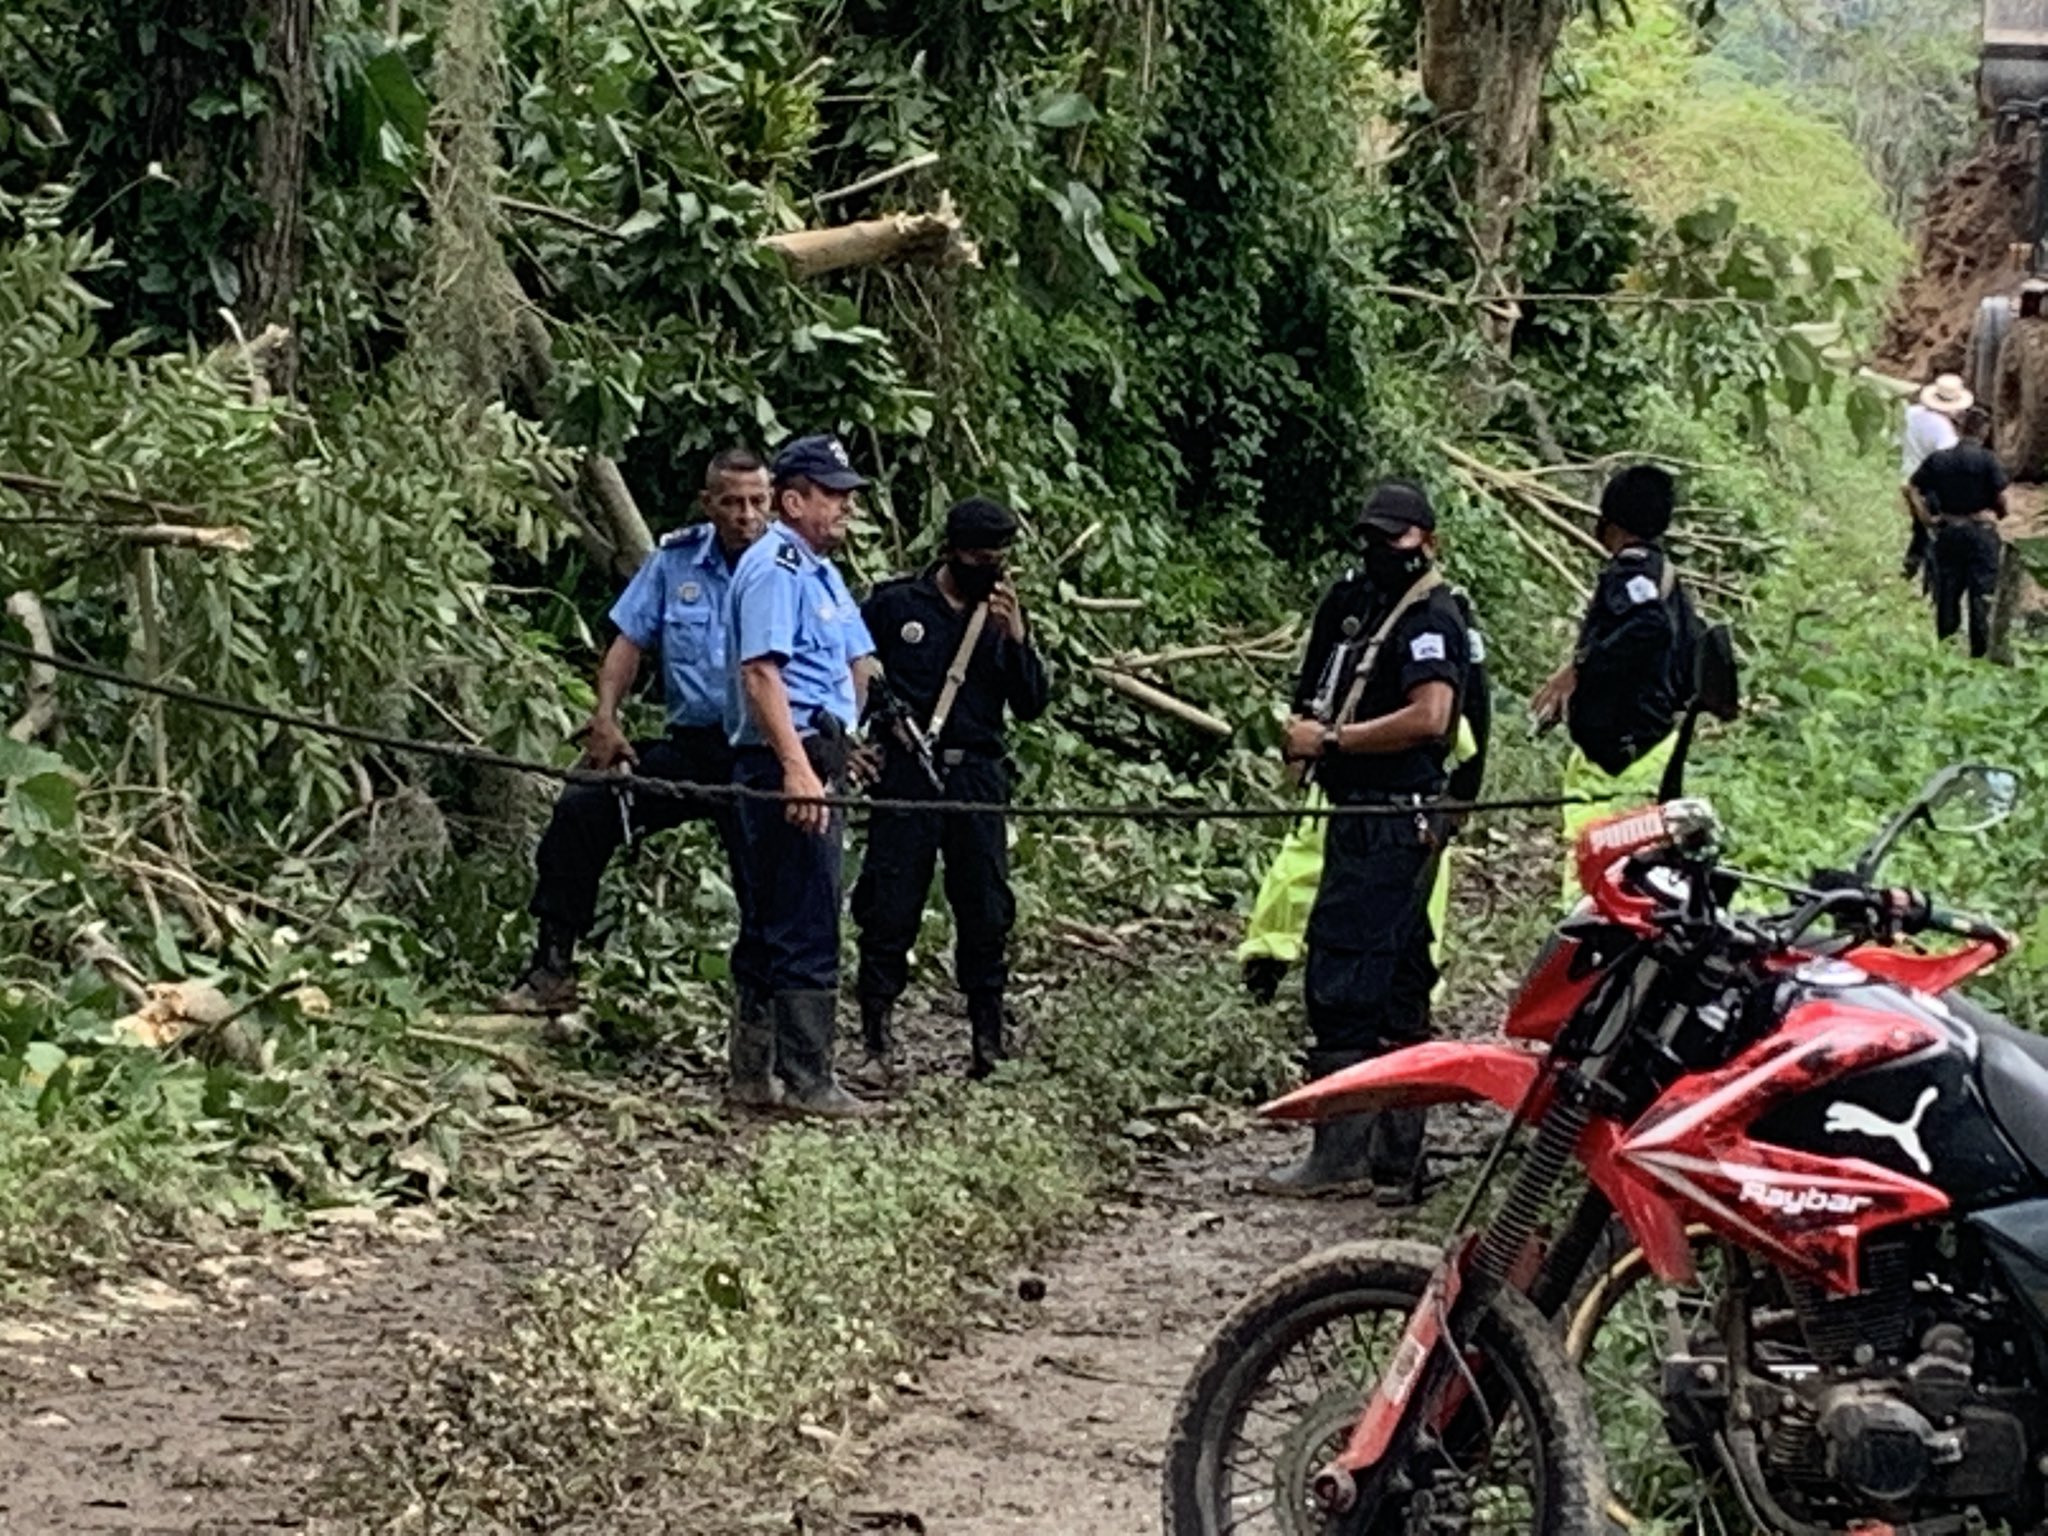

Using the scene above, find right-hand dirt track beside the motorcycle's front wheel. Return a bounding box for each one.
[840,1112,1481,1536]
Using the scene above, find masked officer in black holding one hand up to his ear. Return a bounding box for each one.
[852,500,1051,1083]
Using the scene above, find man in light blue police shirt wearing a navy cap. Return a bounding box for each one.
[725,436,874,1118]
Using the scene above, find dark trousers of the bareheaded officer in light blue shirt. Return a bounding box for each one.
[528,725,762,985]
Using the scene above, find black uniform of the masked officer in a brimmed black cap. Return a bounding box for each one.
[1294,573,1485,1067]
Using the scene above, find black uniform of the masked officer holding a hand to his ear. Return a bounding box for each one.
[852,567,1051,1008]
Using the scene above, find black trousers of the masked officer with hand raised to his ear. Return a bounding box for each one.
[854,754,1018,1004]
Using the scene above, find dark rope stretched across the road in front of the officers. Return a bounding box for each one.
[0,639,1612,823]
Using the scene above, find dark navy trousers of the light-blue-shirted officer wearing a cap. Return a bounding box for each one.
[733,748,846,993]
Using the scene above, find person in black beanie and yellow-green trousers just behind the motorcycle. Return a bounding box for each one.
[1530,465,1700,905]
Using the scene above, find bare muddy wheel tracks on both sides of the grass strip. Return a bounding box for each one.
[0,1028,1477,1536]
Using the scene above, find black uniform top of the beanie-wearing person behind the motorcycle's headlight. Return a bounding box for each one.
[1567,543,1700,774]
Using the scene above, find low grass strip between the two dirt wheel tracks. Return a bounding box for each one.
[340,948,1296,1536]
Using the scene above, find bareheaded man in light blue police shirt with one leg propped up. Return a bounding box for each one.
[500,449,768,1064]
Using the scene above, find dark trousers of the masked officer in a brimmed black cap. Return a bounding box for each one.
[1303,813,1446,1055]
